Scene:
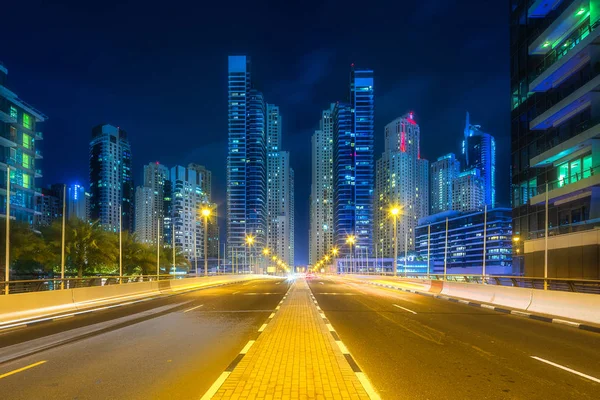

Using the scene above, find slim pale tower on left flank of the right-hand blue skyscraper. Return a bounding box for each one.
[308,103,335,265]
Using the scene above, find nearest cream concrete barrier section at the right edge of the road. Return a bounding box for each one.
[527,290,600,324]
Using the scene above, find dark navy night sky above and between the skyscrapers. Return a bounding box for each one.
[0,0,510,264]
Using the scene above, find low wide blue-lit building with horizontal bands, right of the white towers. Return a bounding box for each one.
[416,208,510,275]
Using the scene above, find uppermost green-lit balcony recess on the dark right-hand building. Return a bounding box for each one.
[529,0,590,55]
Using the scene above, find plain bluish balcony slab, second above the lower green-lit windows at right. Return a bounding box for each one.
[529,72,600,130]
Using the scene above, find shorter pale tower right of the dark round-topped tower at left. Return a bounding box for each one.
[135,162,172,244]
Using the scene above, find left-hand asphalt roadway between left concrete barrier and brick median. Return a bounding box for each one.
[0,279,288,400]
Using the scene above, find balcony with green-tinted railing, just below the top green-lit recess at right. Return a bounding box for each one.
[529,21,600,92]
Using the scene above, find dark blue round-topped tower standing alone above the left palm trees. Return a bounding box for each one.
[90,125,135,232]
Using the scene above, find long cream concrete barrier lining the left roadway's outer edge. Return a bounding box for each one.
[0,275,269,324]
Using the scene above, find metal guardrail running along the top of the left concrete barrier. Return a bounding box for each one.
[0,275,183,295]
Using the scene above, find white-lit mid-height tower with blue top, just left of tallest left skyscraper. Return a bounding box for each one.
[171,165,209,261]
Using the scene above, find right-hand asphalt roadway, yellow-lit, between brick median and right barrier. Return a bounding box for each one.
[310,277,600,399]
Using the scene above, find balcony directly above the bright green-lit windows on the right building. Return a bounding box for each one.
[529,120,600,168]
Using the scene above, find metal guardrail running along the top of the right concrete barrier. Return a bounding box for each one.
[344,272,600,294]
